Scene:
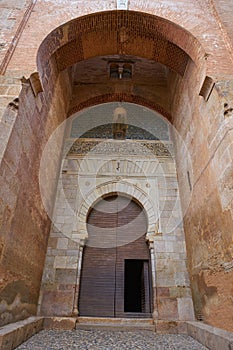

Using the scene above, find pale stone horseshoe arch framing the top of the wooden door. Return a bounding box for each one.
[77,181,158,240]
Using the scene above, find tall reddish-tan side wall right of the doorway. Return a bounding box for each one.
[173,54,233,331]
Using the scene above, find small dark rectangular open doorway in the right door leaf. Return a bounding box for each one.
[124,259,151,314]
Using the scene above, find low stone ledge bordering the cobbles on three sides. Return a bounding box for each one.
[0,316,233,350]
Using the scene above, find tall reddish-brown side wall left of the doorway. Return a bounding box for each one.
[0,67,72,325]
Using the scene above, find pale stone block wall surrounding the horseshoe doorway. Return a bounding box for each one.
[39,140,194,331]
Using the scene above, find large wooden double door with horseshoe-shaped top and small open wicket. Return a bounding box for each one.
[79,195,152,317]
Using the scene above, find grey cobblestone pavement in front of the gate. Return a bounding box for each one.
[17,330,207,350]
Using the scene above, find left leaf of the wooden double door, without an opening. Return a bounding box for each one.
[79,199,117,317]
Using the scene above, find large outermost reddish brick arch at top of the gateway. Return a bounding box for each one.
[37,10,204,95]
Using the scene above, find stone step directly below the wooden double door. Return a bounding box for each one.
[76,317,155,332]
